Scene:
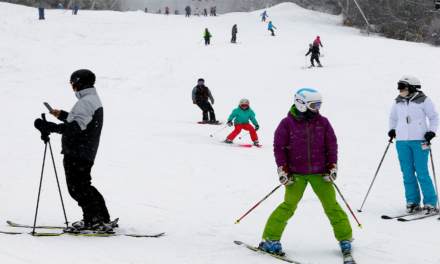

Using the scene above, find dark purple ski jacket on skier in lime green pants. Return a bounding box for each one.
[273,108,338,174]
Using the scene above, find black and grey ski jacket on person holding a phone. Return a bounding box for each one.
[58,87,104,162]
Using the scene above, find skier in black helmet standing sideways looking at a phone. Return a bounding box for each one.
[35,70,112,231]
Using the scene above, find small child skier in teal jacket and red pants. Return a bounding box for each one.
[223,99,260,147]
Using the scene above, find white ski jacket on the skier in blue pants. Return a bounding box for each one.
[389,91,439,141]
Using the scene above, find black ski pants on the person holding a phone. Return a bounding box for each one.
[63,155,110,223]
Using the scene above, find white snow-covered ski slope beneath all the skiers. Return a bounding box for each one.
[0,3,440,264]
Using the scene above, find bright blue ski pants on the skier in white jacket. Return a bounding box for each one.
[396,140,437,206]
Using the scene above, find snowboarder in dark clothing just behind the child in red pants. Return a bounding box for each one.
[191,78,218,123]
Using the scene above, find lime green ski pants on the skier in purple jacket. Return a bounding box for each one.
[263,174,352,241]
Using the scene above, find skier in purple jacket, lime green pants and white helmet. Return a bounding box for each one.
[259,88,354,263]
